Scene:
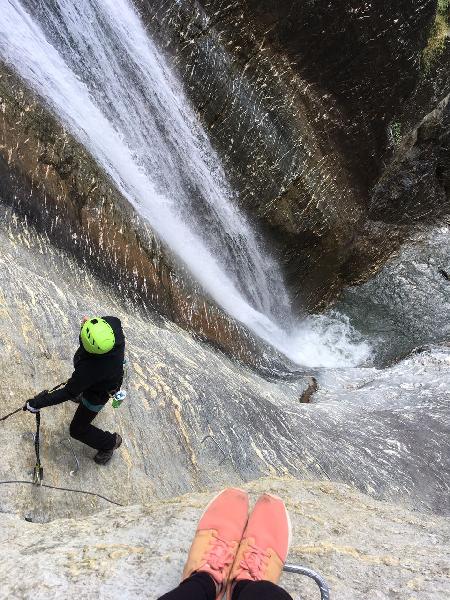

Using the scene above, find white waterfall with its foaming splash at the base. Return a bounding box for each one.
[0,0,369,366]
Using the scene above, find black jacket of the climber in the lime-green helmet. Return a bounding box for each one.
[29,317,125,408]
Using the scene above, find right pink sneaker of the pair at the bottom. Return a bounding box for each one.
[227,494,291,600]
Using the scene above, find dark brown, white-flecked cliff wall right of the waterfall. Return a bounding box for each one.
[137,0,450,308]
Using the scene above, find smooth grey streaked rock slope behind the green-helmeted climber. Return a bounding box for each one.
[0,204,450,520]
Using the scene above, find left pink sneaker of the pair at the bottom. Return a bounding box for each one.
[182,488,248,600]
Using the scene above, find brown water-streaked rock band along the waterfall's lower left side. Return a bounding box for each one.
[0,67,282,365]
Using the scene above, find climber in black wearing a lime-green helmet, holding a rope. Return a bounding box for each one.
[23,317,125,465]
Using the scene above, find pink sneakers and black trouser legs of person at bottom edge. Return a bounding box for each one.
[159,488,292,600]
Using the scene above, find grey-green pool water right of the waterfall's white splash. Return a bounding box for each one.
[337,218,450,364]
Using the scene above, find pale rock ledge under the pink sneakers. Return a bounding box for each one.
[0,478,450,600]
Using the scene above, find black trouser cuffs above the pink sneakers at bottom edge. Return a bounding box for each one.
[159,573,292,600]
